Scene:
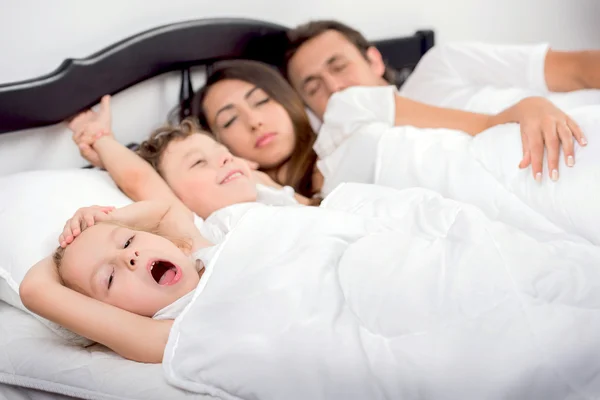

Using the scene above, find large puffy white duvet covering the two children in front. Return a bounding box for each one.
[163,184,600,400]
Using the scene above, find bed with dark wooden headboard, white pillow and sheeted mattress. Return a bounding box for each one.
[0,18,434,400]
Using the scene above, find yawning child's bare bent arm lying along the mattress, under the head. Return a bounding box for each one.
[20,257,173,363]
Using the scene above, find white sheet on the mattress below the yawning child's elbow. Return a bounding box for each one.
[0,302,212,400]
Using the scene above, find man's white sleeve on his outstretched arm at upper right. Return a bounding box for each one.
[400,43,549,111]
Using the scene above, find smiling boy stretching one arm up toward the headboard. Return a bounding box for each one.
[69,96,308,223]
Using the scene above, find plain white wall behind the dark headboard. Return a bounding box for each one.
[0,0,600,175]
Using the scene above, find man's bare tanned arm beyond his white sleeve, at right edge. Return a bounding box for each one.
[544,50,600,92]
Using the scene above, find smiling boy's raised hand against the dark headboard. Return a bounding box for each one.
[68,95,113,167]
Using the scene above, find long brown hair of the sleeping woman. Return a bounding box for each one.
[191,60,317,197]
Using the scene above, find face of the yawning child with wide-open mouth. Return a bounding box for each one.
[59,223,200,317]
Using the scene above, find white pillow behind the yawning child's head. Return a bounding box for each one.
[0,169,131,345]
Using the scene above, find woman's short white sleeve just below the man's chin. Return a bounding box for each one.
[313,86,397,159]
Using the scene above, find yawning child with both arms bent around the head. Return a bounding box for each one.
[20,201,213,363]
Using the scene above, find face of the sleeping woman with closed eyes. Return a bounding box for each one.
[203,79,296,169]
